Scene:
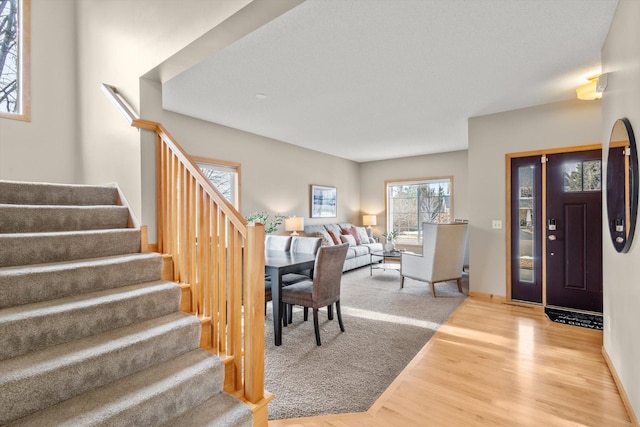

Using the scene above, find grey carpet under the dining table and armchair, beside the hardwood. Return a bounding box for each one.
[265,268,468,419]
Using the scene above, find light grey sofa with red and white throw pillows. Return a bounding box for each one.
[304,222,383,271]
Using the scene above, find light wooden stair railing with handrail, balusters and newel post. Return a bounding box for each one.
[104,85,268,420]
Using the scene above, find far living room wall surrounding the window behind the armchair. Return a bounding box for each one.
[357,150,469,241]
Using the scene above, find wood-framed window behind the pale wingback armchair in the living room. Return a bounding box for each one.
[386,177,453,245]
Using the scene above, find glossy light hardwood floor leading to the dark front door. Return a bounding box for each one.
[269,299,633,427]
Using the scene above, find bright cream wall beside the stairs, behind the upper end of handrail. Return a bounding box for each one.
[74,0,250,215]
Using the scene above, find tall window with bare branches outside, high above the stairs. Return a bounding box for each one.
[0,0,30,121]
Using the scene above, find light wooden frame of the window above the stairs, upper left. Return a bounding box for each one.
[0,0,31,122]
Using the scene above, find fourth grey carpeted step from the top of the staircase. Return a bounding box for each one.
[0,253,162,309]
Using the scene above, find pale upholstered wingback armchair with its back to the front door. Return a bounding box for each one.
[400,222,468,297]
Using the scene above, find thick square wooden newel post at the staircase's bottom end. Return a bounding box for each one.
[244,223,264,403]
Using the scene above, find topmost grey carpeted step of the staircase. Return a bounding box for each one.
[0,180,119,206]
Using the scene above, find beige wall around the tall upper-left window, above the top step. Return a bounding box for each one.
[0,0,77,183]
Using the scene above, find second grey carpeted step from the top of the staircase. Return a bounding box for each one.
[0,205,129,233]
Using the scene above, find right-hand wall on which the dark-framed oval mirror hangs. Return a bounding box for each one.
[601,0,640,417]
